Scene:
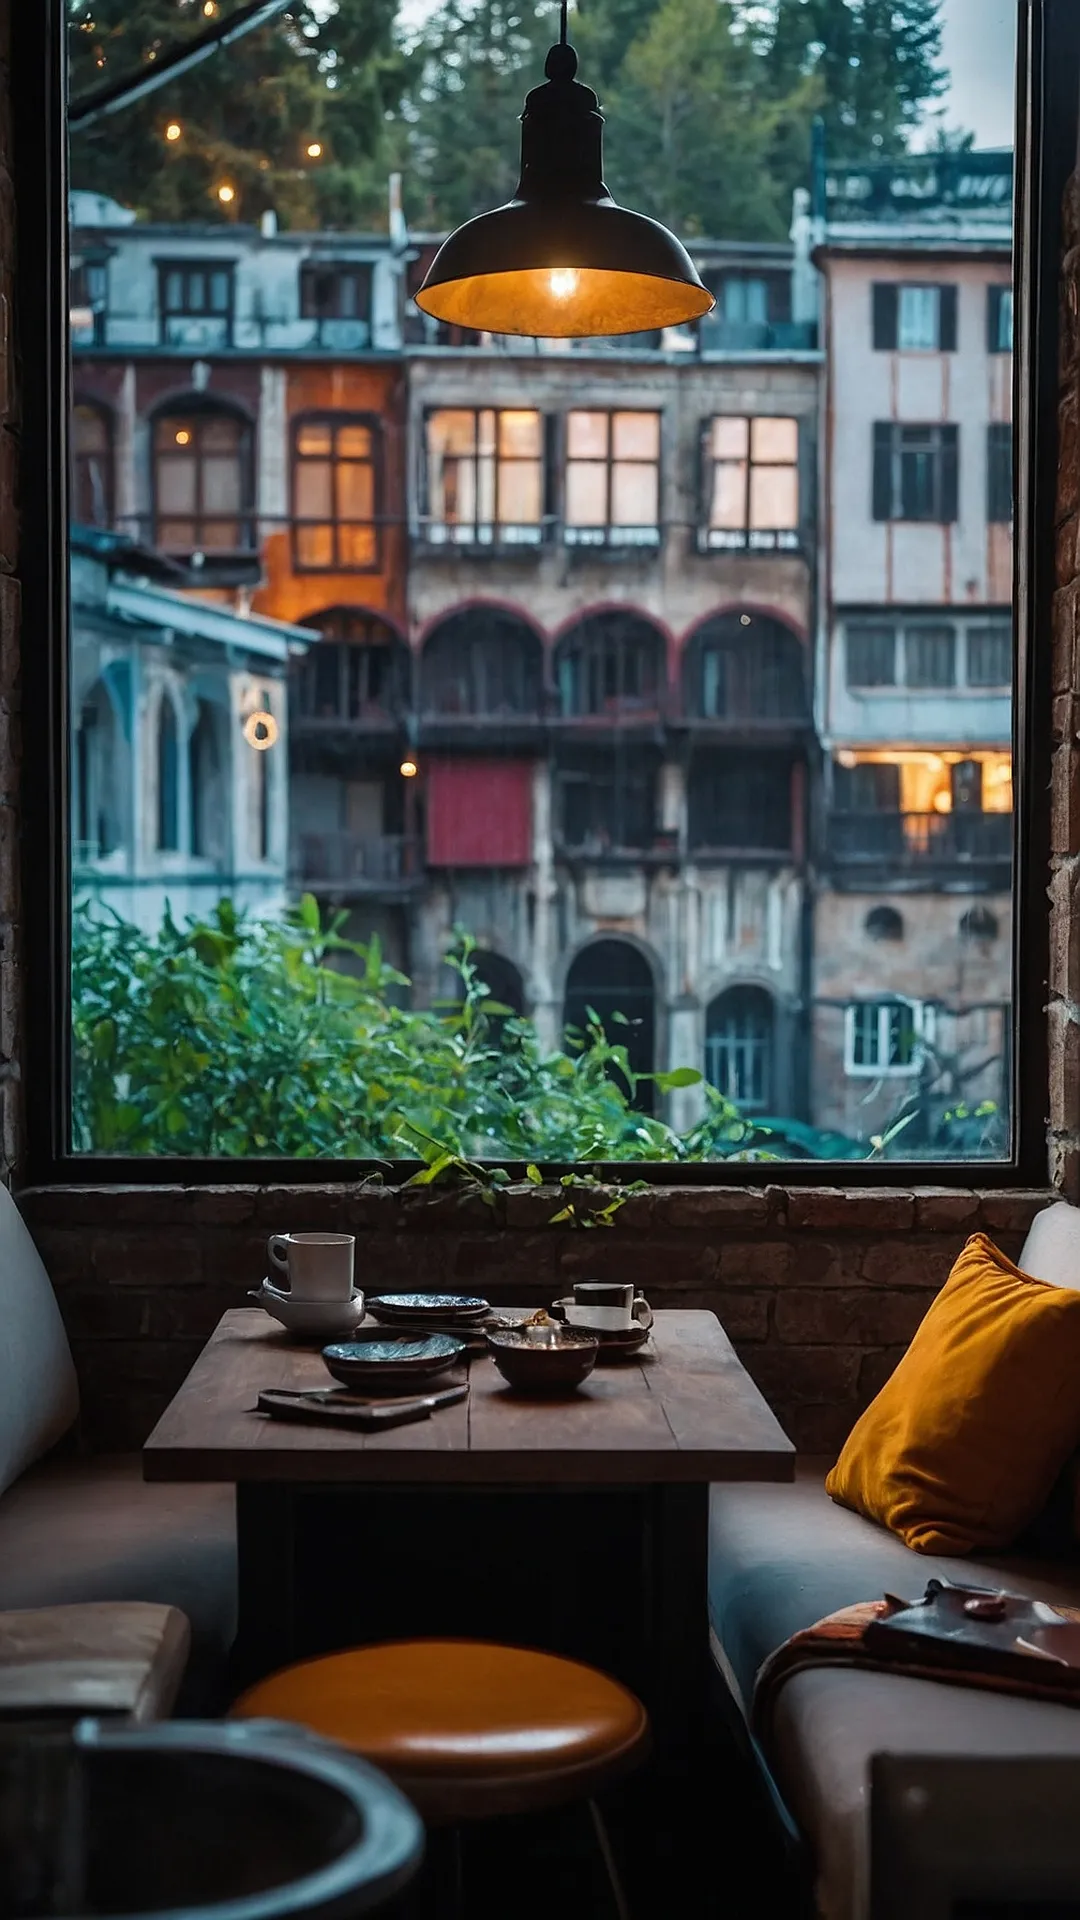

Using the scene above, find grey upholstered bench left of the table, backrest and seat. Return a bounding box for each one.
[0,1188,236,1716]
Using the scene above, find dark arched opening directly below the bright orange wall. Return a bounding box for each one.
[292,607,409,724]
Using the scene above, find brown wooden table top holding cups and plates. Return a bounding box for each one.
[142,1308,796,1486]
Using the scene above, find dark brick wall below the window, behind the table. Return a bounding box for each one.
[21,1187,1047,1452]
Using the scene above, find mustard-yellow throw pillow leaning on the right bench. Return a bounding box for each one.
[824,1233,1080,1553]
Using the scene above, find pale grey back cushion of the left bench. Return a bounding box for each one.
[0,1187,79,1494]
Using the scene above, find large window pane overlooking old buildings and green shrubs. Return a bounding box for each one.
[67,0,1006,1188]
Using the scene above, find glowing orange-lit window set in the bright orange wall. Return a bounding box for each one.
[292,413,379,574]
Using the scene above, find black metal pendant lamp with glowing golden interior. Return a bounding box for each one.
[415,0,715,340]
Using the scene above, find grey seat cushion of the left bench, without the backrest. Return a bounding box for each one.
[0,1455,236,1713]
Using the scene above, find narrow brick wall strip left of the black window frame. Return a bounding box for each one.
[0,0,23,1181]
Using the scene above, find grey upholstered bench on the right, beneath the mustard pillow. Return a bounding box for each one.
[709,1206,1080,1920]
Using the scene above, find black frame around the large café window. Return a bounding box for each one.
[12,0,1080,1188]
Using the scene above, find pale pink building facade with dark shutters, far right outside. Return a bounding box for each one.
[811,154,1013,1152]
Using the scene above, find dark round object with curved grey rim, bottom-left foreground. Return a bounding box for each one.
[0,1720,423,1920]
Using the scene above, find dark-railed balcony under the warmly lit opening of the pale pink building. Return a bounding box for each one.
[828,812,1013,887]
